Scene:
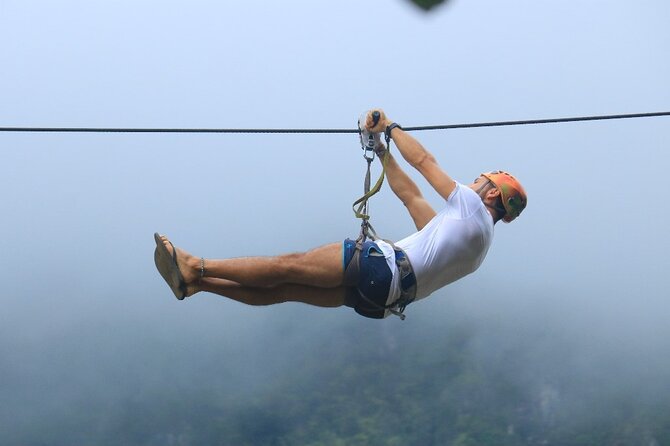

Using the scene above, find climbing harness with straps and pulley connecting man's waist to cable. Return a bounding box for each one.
[344,111,416,320]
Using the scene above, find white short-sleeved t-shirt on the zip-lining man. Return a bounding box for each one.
[386,183,493,302]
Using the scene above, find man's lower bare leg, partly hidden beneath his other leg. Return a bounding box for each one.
[198,278,345,307]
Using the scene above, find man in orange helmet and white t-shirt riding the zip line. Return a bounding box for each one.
[154,110,527,318]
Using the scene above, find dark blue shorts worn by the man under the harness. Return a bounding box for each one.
[342,239,393,319]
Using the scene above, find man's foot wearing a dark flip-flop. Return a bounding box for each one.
[154,233,201,300]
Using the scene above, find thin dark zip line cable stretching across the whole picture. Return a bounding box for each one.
[0,112,670,133]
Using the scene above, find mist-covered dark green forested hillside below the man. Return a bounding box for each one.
[7,321,670,446]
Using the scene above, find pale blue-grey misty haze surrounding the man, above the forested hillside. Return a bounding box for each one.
[0,0,670,444]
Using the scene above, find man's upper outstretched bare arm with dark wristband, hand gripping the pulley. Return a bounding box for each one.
[366,110,456,200]
